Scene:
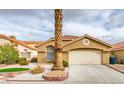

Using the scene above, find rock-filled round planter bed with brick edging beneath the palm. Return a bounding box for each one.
[43,70,68,81]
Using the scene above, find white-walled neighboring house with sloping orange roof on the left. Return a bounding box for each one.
[0,34,37,60]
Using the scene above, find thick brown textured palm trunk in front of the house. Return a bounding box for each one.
[52,9,64,70]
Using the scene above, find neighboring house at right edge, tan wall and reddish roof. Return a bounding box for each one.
[111,42,124,63]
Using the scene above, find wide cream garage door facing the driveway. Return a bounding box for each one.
[69,49,102,64]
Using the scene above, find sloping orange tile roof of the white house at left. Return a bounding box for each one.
[0,34,37,51]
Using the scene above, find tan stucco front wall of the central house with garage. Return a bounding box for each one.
[38,38,110,64]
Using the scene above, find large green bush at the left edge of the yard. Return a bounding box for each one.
[0,44,19,64]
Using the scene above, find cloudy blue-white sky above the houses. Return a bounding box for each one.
[0,9,124,44]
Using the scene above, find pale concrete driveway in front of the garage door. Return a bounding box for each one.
[66,65,124,83]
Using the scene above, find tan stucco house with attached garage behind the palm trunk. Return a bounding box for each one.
[37,35,111,64]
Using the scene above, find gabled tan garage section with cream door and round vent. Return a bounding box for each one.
[63,35,111,64]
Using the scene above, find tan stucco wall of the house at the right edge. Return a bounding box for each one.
[112,50,124,63]
